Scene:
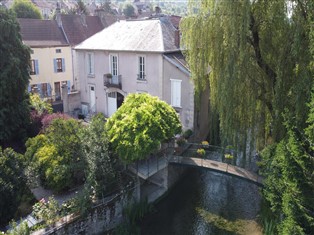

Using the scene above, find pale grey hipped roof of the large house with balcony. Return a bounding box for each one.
[76,16,179,52]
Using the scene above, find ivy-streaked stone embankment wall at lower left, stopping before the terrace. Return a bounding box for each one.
[32,185,139,235]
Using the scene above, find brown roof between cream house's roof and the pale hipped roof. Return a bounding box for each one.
[60,15,104,45]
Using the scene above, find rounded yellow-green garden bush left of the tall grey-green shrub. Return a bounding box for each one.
[25,119,85,191]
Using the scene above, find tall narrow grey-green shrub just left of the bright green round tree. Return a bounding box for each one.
[82,113,115,197]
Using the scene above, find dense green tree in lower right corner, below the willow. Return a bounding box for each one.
[262,107,314,234]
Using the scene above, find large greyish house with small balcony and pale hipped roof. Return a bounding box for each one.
[75,16,205,130]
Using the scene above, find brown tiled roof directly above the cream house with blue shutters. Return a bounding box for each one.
[18,19,68,47]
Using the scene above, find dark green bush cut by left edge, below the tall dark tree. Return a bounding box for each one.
[0,146,26,225]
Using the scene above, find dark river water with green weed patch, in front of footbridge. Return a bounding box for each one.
[140,166,262,235]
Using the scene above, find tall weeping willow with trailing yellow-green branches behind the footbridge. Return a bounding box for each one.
[181,0,313,148]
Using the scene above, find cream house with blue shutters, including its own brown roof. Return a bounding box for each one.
[18,19,73,101]
